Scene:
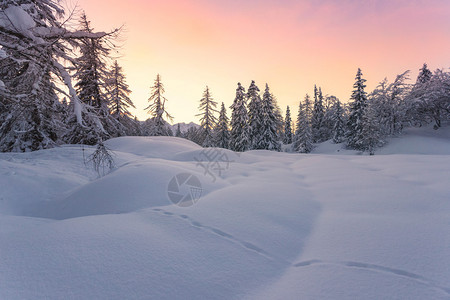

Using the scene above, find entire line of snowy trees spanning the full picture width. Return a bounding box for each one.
[0,0,450,153]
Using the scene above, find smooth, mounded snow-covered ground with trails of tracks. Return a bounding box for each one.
[0,128,450,299]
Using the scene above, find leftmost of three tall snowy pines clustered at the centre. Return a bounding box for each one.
[230,82,250,152]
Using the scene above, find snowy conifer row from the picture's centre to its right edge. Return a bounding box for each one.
[157,64,450,154]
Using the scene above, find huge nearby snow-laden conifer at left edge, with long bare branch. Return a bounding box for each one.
[0,0,118,151]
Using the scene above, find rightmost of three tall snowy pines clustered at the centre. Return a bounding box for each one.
[258,83,281,151]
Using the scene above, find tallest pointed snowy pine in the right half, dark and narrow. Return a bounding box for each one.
[346,68,367,150]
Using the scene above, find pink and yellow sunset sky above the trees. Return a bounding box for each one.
[77,0,450,123]
